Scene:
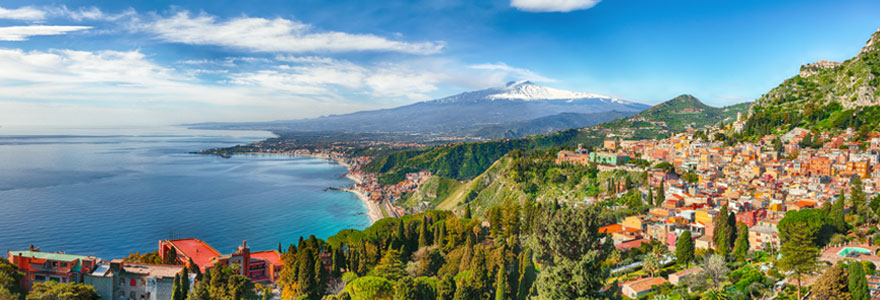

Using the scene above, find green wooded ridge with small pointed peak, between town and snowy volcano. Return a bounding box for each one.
[366,95,749,184]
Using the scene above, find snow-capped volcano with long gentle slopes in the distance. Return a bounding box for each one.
[190,81,649,138]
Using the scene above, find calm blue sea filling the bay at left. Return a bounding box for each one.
[0,127,369,259]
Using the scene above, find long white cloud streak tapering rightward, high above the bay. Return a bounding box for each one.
[142,11,445,54]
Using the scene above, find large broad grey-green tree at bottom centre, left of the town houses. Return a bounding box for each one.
[530,207,616,299]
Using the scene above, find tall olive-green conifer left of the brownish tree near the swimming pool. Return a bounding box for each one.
[777,220,819,299]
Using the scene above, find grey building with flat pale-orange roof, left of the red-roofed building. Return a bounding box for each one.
[83,260,185,300]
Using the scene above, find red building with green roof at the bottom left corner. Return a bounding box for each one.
[6,247,99,290]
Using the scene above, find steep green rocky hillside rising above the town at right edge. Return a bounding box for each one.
[745,27,880,137]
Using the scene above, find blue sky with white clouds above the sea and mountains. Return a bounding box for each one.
[0,0,880,126]
